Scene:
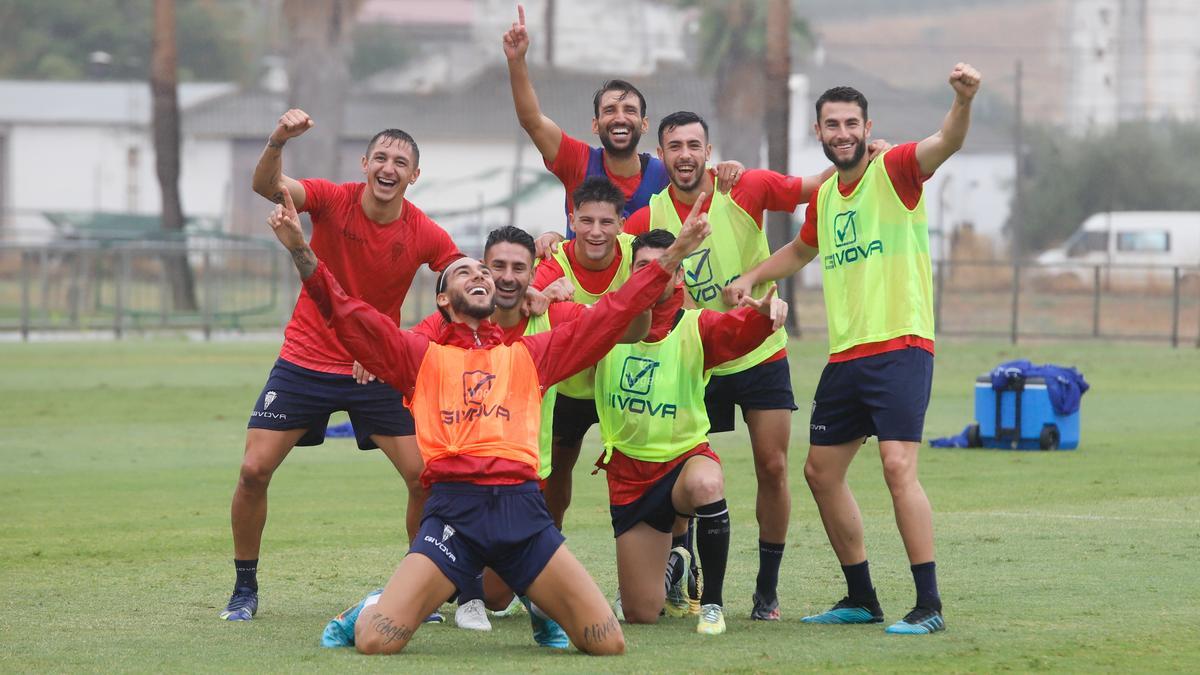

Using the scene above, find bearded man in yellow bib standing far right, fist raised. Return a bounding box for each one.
[727,64,980,634]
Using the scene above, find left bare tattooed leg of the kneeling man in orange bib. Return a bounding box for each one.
[354,554,454,653]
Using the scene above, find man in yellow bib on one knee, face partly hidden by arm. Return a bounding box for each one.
[595,228,787,635]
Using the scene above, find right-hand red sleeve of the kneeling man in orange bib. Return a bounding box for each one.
[525,264,672,387]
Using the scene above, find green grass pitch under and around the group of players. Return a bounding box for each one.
[0,340,1200,673]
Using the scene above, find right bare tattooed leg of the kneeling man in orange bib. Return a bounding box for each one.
[528,545,628,656]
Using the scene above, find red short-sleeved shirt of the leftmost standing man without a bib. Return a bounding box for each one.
[280,178,462,375]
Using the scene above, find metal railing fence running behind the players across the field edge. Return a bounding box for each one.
[0,238,1200,347]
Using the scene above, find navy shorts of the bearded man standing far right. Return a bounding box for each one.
[809,347,934,446]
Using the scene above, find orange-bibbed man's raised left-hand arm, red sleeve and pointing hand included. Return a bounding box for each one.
[266,192,430,395]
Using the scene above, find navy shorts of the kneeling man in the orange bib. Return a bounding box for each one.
[408,480,565,596]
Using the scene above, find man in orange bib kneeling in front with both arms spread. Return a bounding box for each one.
[269,182,708,655]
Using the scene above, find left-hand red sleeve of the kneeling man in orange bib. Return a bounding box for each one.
[304,263,430,396]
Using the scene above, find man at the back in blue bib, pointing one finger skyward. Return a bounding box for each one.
[504,5,743,236]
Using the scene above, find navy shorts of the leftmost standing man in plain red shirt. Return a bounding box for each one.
[246,359,416,450]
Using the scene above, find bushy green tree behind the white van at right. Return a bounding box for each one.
[1008,123,1200,253]
